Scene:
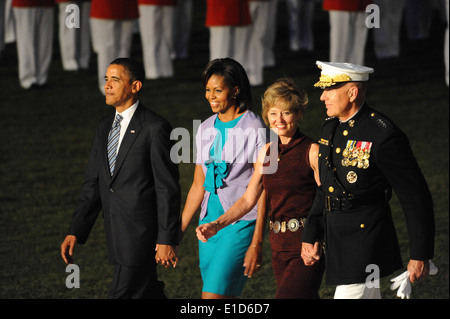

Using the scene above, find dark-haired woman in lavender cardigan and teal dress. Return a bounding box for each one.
[181,58,267,299]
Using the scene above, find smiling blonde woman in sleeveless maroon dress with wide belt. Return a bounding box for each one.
[197,79,324,299]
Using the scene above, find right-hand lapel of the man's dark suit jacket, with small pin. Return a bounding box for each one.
[107,103,144,182]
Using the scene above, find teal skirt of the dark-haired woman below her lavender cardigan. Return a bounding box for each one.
[199,194,256,297]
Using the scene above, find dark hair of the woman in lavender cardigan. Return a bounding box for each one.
[202,58,252,113]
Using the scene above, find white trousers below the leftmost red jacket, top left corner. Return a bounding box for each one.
[13,7,53,89]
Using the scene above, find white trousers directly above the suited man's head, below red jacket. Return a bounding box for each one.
[90,18,136,94]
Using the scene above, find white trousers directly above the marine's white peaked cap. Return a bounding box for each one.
[329,10,368,65]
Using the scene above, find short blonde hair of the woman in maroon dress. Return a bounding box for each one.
[261,78,308,127]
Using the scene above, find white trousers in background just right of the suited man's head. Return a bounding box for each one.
[139,5,175,79]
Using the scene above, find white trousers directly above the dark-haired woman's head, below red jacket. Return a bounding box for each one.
[209,26,250,70]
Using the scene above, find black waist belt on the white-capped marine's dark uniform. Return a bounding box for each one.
[325,191,388,212]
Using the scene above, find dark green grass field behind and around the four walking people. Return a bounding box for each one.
[0,1,449,299]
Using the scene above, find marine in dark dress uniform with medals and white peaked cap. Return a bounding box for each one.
[302,61,434,298]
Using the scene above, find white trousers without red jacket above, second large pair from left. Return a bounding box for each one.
[59,2,91,71]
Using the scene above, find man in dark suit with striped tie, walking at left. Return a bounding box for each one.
[61,58,180,298]
